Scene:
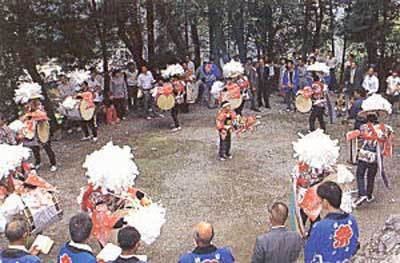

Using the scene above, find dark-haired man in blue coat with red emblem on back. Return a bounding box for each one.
[304,182,359,263]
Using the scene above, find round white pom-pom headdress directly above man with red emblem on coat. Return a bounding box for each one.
[293,129,340,170]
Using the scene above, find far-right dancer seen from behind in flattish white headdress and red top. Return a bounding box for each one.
[347,94,393,207]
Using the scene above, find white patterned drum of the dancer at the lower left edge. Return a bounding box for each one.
[21,188,63,234]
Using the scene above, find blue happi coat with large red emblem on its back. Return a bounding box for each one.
[304,213,359,263]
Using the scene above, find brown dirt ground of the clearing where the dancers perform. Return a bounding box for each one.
[2,97,400,263]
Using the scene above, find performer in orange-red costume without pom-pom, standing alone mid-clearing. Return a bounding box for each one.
[216,101,236,161]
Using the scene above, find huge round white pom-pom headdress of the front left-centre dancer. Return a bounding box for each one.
[83,142,139,193]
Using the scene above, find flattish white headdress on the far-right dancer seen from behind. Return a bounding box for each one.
[358,94,392,117]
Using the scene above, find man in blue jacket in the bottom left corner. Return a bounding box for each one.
[0,218,42,263]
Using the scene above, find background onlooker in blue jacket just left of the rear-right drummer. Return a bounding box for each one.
[282,60,299,111]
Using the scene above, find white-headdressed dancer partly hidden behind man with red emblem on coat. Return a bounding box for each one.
[291,129,354,236]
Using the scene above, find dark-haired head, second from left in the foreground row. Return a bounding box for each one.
[69,213,93,243]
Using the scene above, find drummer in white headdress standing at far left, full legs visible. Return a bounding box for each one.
[15,82,57,172]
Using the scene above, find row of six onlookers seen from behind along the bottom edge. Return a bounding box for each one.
[0,182,359,263]
